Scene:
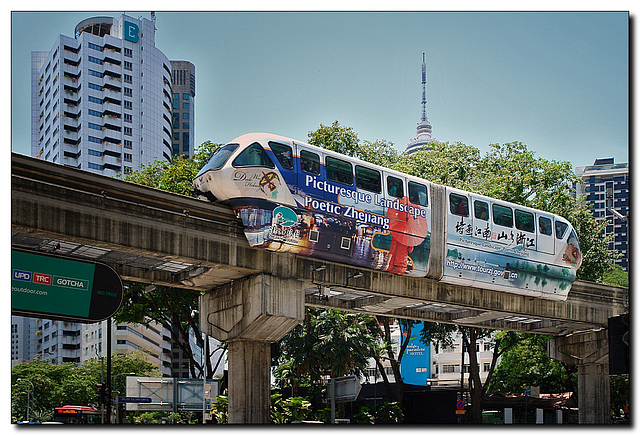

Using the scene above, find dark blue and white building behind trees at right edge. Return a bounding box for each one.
[576,158,629,270]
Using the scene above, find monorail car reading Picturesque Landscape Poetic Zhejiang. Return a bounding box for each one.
[194,133,430,276]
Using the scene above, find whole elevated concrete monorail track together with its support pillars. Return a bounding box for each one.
[11,154,629,424]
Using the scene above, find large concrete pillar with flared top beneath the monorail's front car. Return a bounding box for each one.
[200,275,304,424]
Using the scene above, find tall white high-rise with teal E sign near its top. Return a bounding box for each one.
[31,15,172,176]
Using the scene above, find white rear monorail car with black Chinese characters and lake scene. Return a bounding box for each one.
[442,188,582,300]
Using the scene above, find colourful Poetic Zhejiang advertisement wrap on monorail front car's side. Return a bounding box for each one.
[230,163,429,276]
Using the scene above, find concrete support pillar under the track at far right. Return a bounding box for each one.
[548,329,611,424]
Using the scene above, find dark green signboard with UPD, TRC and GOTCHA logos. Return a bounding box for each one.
[11,249,123,323]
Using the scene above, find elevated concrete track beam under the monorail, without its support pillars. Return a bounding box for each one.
[11,154,628,335]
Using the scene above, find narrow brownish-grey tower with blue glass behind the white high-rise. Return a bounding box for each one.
[171,60,196,158]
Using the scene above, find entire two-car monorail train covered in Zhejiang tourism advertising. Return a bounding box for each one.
[193,133,582,300]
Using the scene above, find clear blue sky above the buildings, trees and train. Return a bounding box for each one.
[11,11,629,166]
